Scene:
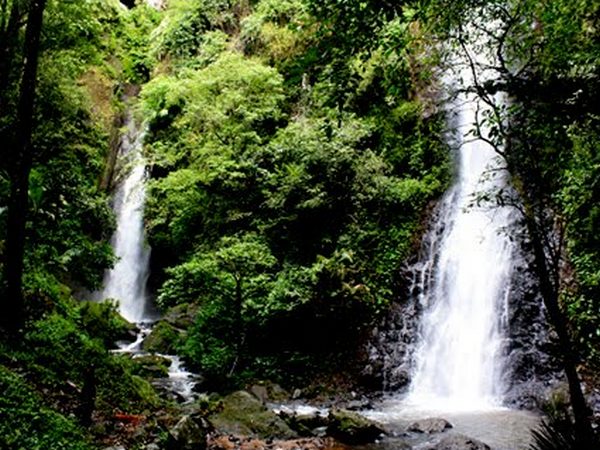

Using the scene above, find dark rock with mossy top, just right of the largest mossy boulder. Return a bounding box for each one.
[327,409,385,444]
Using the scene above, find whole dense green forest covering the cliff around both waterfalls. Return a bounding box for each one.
[0,0,600,449]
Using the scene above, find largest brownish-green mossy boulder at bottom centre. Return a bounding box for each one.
[209,391,298,439]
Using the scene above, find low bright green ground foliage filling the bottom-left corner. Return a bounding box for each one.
[0,366,93,450]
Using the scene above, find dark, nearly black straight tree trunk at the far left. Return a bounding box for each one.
[2,0,46,332]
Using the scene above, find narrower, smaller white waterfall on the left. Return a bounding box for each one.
[101,117,150,322]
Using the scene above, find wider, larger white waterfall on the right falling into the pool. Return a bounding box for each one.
[406,51,515,410]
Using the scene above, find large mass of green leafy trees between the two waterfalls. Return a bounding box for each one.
[141,0,448,380]
